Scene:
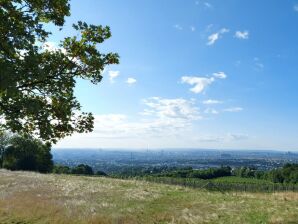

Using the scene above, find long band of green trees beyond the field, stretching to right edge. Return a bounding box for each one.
[112,164,298,184]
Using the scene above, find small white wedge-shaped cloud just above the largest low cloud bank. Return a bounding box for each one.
[181,72,227,93]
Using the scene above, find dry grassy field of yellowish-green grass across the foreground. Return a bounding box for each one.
[0,170,298,224]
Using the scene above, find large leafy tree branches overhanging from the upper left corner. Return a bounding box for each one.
[0,0,119,142]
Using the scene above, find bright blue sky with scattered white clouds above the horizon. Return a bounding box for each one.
[54,0,298,150]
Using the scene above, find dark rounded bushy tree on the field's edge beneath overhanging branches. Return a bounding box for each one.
[3,136,53,173]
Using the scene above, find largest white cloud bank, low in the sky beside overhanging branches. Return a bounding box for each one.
[57,97,201,141]
